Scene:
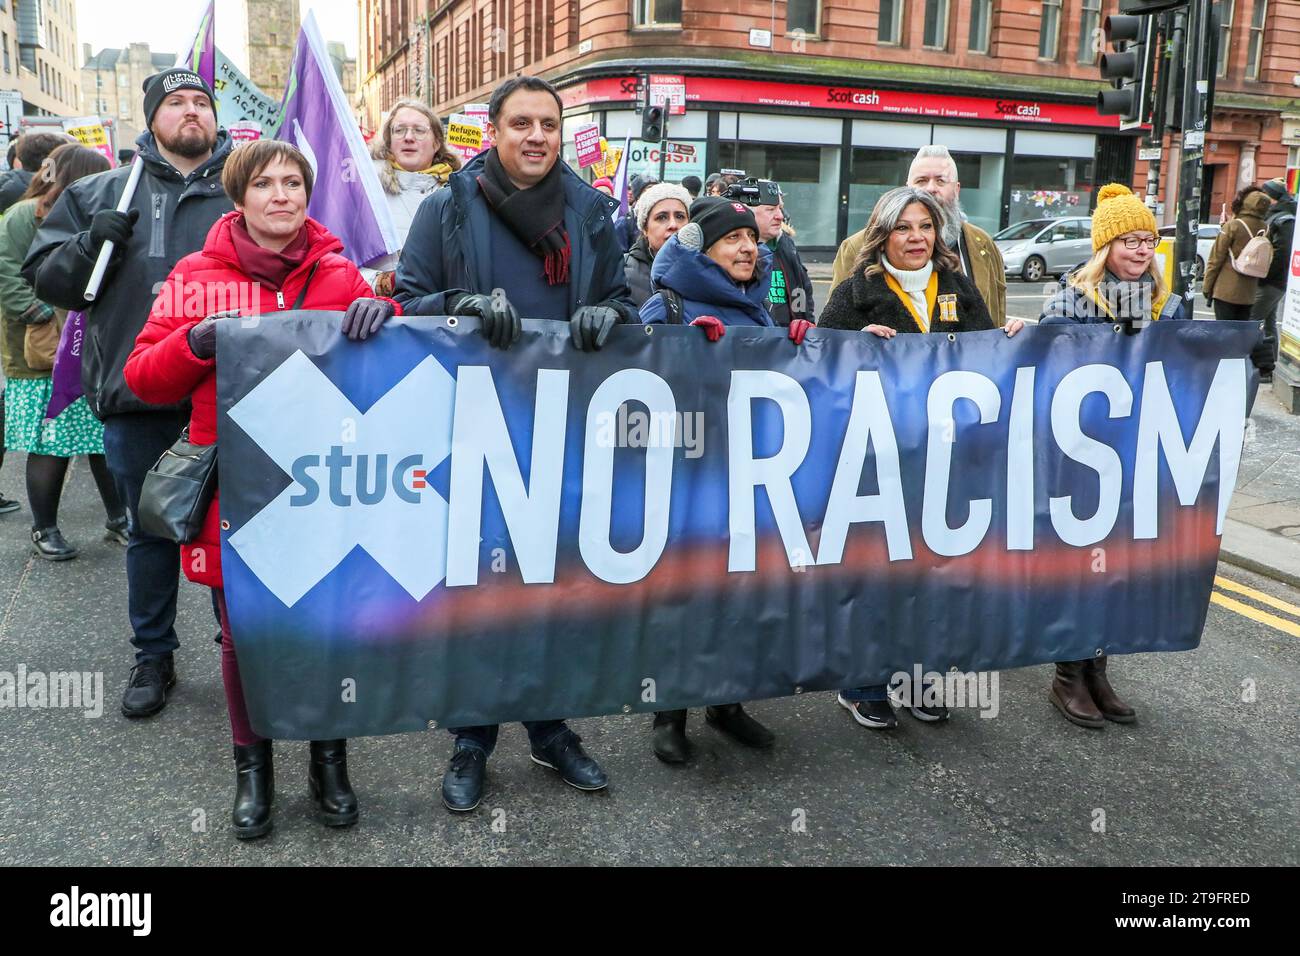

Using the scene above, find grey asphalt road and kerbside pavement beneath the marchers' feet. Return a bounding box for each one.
[0,338,1300,866]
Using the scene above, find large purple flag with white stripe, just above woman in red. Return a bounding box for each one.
[274,12,399,265]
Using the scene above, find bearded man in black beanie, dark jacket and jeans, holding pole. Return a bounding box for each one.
[23,69,231,717]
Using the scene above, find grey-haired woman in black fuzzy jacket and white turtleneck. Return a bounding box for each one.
[818,186,1024,730]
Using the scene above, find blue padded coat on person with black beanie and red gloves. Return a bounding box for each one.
[641,234,776,328]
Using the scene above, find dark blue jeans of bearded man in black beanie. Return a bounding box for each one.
[104,411,190,661]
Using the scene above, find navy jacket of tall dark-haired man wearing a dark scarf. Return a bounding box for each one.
[393,153,637,323]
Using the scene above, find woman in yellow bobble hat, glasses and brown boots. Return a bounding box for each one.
[1039,183,1187,728]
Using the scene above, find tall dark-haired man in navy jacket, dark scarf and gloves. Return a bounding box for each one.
[394,77,637,812]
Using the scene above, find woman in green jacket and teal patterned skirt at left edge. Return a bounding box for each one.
[0,143,127,561]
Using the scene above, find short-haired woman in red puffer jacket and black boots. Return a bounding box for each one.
[126,140,400,839]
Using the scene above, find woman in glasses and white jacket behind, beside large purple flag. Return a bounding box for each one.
[361,99,460,295]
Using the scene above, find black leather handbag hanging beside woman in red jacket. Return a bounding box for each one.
[135,425,217,545]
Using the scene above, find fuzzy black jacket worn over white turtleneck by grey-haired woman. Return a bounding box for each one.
[816,267,993,332]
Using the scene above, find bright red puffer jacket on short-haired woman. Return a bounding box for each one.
[124,212,400,588]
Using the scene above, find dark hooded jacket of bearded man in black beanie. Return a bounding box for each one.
[22,129,234,419]
